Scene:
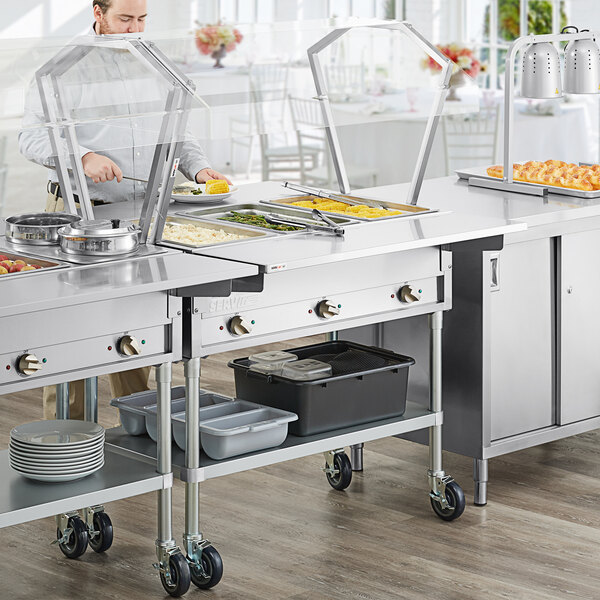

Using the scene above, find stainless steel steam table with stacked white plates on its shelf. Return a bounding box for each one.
[0,237,257,584]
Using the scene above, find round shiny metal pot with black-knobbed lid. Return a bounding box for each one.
[58,219,140,256]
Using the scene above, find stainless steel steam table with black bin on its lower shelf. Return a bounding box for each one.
[107,183,525,587]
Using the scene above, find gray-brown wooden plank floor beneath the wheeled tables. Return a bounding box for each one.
[0,341,600,600]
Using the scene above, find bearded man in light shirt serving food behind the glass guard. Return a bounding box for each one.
[19,0,231,419]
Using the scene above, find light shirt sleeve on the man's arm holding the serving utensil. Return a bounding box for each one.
[19,81,92,166]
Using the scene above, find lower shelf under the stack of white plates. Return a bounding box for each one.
[0,448,172,527]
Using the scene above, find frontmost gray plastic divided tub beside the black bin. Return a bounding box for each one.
[200,407,298,460]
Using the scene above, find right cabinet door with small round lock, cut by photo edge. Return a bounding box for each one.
[558,231,600,425]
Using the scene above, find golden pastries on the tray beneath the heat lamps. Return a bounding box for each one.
[487,160,600,192]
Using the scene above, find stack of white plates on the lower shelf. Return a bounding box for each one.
[9,421,104,482]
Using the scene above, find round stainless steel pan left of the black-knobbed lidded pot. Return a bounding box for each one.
[5,213,81,246]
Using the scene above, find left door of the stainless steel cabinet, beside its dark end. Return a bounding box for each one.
[490,238,556,441]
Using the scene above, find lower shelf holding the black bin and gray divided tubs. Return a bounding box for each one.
[106,402,442,481]
